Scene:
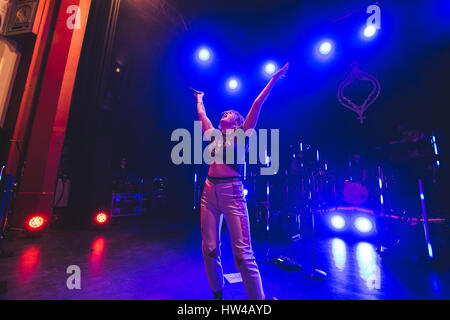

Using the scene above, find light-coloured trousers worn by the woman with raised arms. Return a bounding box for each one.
[201,178,265,300]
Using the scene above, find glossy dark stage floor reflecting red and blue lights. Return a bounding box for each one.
[0,219,450,300]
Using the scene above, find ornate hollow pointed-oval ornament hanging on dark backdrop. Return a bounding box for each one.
[337,62,380,124]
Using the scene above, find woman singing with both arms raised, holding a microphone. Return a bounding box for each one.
[195,63,289,300]
